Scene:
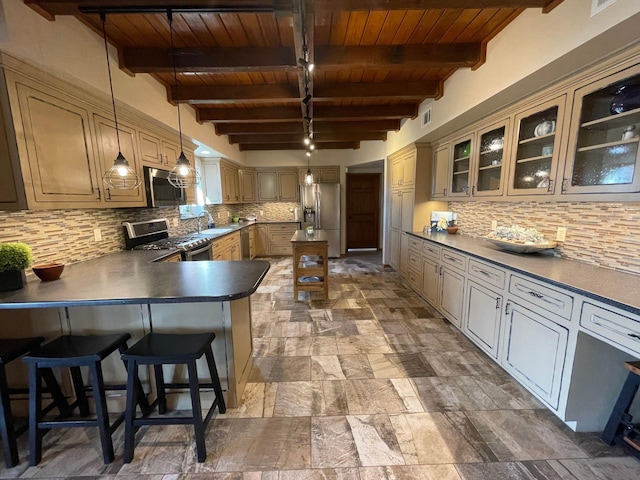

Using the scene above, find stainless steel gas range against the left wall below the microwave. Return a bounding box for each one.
[122,218,213,261]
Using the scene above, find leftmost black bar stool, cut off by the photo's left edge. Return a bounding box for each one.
[0,337,70,468]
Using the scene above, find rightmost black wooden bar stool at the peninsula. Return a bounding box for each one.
[122,333,226,463]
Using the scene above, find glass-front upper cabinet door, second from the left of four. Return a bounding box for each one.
[471,120,509,196]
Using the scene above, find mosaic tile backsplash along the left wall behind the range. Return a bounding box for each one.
[0,202,299,264]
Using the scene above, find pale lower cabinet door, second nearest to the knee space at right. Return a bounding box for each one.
[462,281,503,358]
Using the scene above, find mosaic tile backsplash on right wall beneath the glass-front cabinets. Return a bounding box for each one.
[449,202,640,273]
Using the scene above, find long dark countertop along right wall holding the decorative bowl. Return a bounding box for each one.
[407,232,640,315]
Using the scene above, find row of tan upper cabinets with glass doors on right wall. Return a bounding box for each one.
[432,52,640,201]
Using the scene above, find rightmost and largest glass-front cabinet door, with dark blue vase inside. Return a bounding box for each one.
[562,68,640,193]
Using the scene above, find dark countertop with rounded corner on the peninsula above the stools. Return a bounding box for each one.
[0,250,269,309]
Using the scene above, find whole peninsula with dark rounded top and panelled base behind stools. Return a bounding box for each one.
[0,251,269,411]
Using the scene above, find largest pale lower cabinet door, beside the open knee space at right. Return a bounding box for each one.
[500,301,569,409]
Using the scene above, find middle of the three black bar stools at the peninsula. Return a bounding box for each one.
[22,333,149,466]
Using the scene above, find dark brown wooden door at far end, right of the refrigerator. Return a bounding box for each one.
[347,173,381,250]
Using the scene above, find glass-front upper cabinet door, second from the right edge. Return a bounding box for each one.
[507,96,566,195]
